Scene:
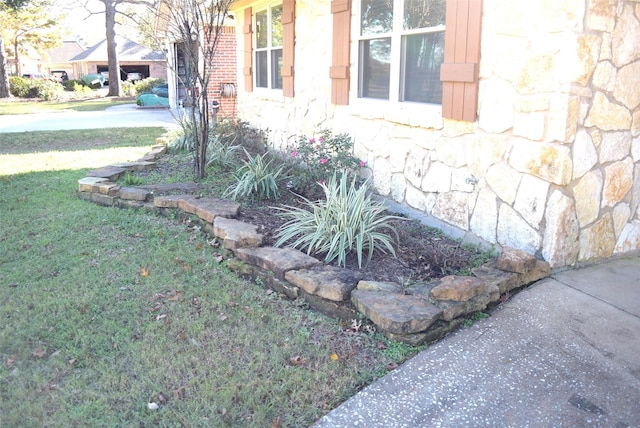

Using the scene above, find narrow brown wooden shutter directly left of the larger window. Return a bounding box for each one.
[329,0,351,105]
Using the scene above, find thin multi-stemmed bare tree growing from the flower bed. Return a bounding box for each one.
[157,0,233,179]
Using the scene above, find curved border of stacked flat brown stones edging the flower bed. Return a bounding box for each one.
[78,139,550,345]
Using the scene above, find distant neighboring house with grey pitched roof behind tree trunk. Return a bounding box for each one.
[71,36,167,80]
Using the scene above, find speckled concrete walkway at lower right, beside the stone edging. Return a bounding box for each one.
[315,255,640,428]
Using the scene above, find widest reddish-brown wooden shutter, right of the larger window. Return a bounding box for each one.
[440,0,482,122]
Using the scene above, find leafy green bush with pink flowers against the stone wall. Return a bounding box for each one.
[291,130,365,194]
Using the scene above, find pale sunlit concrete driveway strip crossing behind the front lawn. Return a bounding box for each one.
[0,104,177,133]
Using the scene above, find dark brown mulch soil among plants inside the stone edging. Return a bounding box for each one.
[140,151,487,285]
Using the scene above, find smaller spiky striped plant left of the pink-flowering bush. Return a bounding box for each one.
[224,149,287,200]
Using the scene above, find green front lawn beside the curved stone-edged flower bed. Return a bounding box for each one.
[0,129,414,427]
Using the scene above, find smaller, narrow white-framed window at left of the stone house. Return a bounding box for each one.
[254,4,283,89]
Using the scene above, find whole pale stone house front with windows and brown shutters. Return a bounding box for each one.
[166,0,640,268]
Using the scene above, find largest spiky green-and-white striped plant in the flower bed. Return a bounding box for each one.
[275,172,401,267]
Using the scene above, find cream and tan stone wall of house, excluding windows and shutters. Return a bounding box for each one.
[230,0,640,267]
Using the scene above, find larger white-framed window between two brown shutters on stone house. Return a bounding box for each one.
[358,0,445,104]
